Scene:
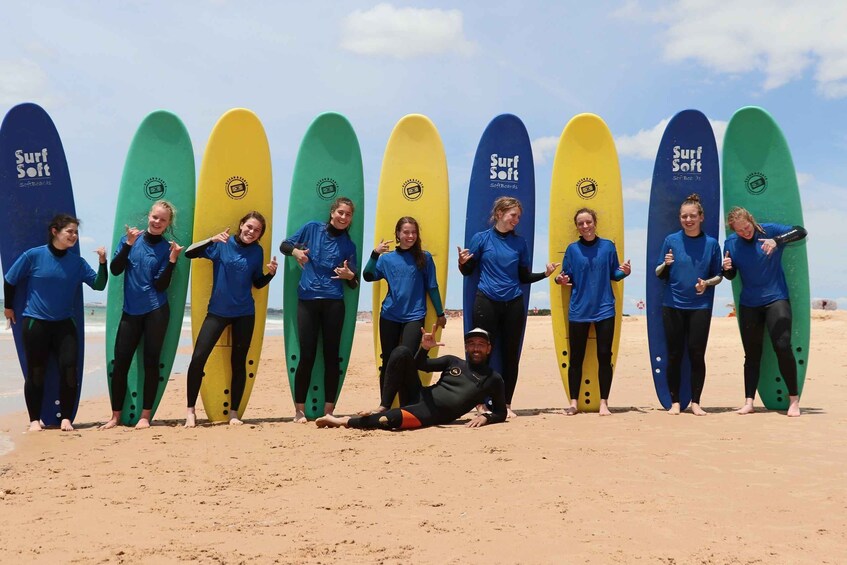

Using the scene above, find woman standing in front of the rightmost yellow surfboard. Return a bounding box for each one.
[555,208,632,416]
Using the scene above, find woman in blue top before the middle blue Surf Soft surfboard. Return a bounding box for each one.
[459,196,559,418]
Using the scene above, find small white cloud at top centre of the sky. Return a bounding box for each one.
[341,4,476,59]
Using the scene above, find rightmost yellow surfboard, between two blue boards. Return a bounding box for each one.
[549,114,624,412]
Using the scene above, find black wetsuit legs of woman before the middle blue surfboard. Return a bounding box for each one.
[473,292,526,404]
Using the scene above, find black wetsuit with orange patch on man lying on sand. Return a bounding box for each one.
[347,345,506,430]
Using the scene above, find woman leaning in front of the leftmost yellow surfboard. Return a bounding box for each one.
[185,210,277,428]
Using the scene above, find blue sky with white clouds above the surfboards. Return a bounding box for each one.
[0,0,847,312]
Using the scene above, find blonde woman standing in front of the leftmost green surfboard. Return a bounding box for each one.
[100,200,183,430]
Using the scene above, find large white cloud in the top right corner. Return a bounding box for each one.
[657,0,847,98]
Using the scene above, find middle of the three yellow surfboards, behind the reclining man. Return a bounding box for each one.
[372,114,450,396]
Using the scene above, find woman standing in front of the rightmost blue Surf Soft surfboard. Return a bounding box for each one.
[656,194,723,416]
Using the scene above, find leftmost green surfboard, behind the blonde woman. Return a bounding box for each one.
[106,110,195,426]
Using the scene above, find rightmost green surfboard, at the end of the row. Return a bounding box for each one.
[723,106,811,410]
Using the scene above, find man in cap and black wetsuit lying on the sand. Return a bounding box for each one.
[315,326,506,430]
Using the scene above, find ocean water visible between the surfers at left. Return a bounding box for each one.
[0,304,283,418]
